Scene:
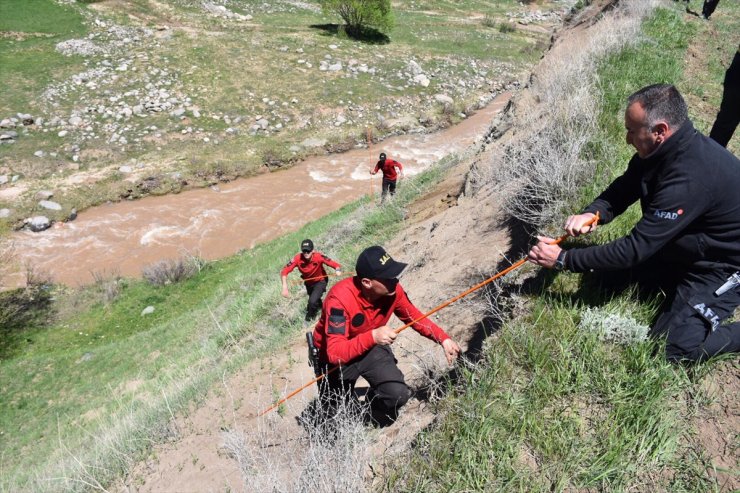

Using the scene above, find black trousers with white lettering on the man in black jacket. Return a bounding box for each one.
[652,267,740,362]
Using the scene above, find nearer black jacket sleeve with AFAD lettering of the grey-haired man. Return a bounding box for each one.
[565,169,712,272]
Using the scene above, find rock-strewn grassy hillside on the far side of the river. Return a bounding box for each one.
[0,0,548,226]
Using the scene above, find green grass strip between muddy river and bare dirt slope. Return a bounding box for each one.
[0,152,456,491]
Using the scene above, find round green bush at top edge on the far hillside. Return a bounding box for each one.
[319,0,393,38]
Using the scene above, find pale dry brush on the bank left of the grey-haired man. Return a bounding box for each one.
[471,0,657,227]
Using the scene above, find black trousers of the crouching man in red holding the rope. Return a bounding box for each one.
[319,346,411,416]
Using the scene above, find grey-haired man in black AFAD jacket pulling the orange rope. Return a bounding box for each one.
[529,84,740,361]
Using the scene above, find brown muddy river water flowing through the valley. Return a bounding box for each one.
[5,94,510,287]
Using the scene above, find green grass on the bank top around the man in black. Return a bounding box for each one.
[385,3,737,492]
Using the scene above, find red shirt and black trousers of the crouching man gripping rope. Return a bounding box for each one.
[313,277,450,412]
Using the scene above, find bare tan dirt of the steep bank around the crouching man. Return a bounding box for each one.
[117,1,740,492]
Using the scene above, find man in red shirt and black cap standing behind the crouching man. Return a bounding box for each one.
[280,240,342,321]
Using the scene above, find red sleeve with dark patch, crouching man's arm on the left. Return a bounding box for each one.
[322,296,375,365]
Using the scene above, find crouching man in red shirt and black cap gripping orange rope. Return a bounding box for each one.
[313,246,460,422]
